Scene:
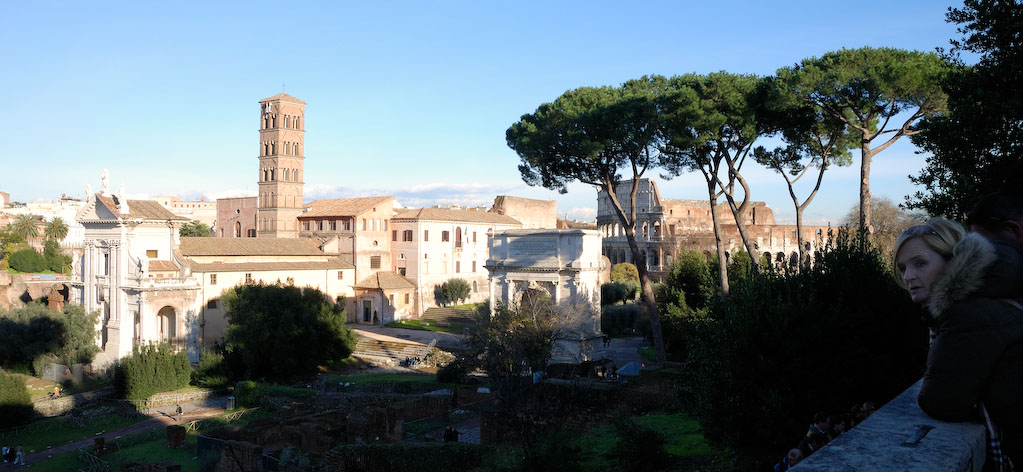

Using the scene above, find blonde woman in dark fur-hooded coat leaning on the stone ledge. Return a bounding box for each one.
[894,218,1023,467]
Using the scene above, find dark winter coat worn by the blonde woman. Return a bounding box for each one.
[917,233,1023,461]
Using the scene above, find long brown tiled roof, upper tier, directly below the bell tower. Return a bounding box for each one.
[180,238,323,253]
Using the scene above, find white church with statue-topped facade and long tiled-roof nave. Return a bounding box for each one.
[71,176,355,366]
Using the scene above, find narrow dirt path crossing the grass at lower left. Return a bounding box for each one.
[0,399,224,466]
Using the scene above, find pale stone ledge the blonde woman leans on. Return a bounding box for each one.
[791,382,986,472]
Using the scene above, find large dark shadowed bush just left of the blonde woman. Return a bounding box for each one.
[683,230,927,468]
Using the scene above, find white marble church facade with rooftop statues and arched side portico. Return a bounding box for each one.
[72,175,201,366]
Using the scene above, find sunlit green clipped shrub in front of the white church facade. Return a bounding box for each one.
[116,344,191,400]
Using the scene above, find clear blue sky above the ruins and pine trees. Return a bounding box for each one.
[0,1,958,222]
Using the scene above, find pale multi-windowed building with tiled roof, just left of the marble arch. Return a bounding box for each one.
[391,208,522,314]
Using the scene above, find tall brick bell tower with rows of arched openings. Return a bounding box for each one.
[256,93,306,238]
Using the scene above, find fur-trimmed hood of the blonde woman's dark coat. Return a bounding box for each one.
[927,232,1023,318]
